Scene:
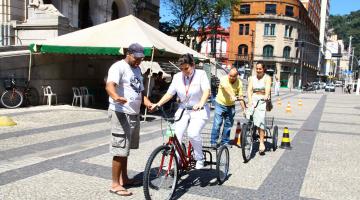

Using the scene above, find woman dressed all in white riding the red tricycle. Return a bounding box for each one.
[151,54,210,169]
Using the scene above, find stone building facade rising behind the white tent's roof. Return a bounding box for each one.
[0,0,160,46]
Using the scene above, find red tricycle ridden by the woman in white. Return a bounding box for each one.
[143,105,230,200]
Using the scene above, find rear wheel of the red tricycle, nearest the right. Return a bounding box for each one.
[216,145,230,184]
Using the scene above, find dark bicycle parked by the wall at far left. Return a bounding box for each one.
[0,75,39,108]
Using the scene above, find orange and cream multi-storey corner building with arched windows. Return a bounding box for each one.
[229,0,319,87]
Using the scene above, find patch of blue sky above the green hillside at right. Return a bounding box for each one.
[330,0,360,15]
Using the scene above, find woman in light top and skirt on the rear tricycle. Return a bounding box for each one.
[248,62,271,154]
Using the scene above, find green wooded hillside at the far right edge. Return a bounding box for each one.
[329,10,360,58]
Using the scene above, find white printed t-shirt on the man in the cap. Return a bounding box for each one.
[106,60,144,115]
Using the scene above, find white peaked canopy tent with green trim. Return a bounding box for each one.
[29,15,207,117]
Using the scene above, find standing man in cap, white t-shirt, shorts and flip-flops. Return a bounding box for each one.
[106,43,152,196]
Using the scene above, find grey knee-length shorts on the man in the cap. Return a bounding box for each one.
[109,110,140,157]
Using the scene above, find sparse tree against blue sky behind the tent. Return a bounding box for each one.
[160,0,239,45]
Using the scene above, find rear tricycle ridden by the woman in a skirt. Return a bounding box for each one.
[241,99,278,163]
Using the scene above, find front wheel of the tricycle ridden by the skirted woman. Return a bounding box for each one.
[241,124,254,163]
